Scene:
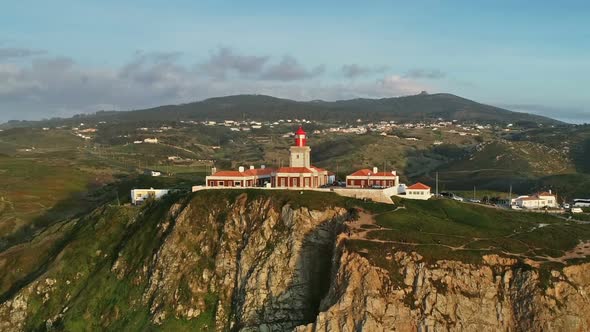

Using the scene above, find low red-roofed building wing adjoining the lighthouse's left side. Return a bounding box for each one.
[205,165,274,188]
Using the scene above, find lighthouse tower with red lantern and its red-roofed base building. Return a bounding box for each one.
[274,127,328,188]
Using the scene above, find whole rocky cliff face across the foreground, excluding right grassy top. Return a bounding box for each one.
[0,193,590,331]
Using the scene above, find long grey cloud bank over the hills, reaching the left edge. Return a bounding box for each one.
[0,50,431,121]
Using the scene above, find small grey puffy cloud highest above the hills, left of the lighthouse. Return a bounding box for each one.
[198,47,269,78]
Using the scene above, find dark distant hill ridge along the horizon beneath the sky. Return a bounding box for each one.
[4,93,561,128]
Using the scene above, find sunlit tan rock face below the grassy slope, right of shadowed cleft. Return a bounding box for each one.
[296,251,590,331]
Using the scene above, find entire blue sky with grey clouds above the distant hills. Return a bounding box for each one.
[0,0,590,123]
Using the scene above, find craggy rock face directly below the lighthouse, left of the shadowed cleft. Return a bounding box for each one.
[130,196,347,331]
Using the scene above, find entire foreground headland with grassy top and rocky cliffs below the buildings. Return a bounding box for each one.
[0,190,590,331]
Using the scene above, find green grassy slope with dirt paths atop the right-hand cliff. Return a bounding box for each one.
[346,200,590,263]
